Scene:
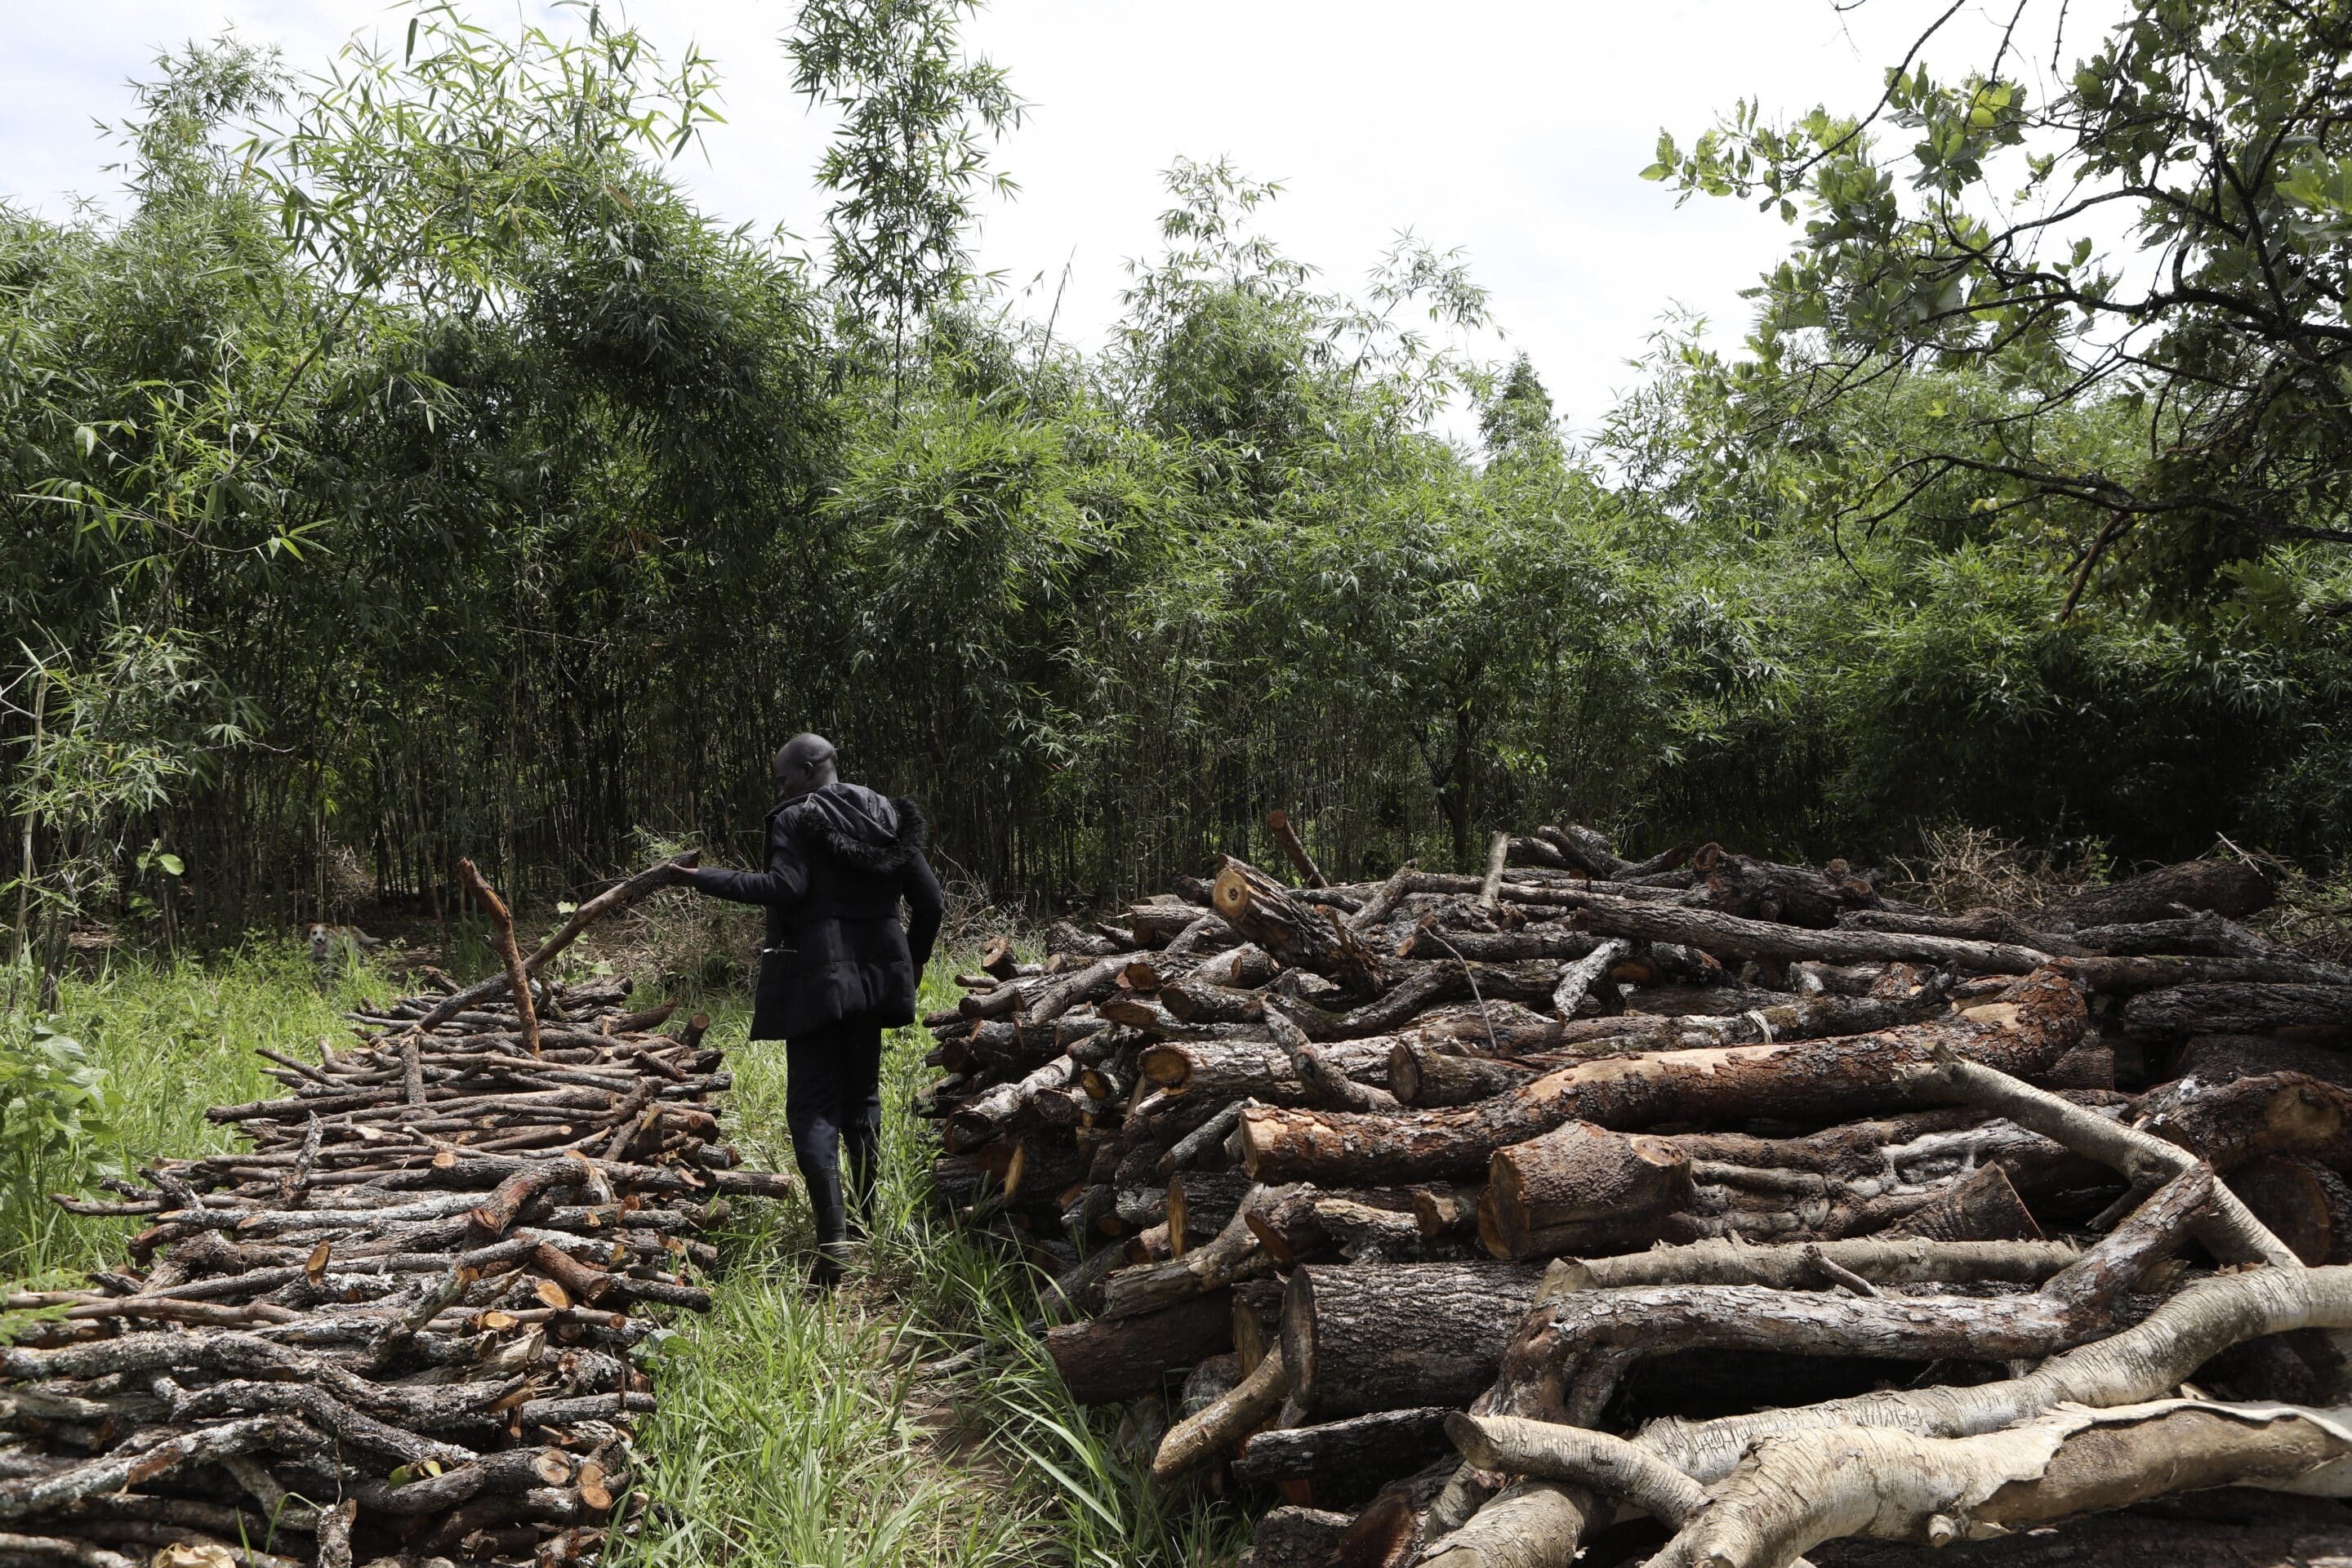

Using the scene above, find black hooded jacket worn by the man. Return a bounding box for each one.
[694,783,943,1039]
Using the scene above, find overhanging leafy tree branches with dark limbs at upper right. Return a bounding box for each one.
[1644,0,2352,607]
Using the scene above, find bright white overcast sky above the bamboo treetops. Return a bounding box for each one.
[0,0,2124,442]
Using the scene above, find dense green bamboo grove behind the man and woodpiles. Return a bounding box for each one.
[0,0,2352,968]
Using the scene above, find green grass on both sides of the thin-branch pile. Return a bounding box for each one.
[0,947,1245,1568]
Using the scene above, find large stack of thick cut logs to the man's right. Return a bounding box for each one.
[929,827,2352,1568]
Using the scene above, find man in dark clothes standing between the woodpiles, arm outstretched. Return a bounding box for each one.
[694,736,943,1286]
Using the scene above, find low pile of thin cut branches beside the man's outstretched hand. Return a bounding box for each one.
[0,865,786,1568]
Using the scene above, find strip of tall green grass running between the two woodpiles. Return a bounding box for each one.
[617,959,1245,1568]
